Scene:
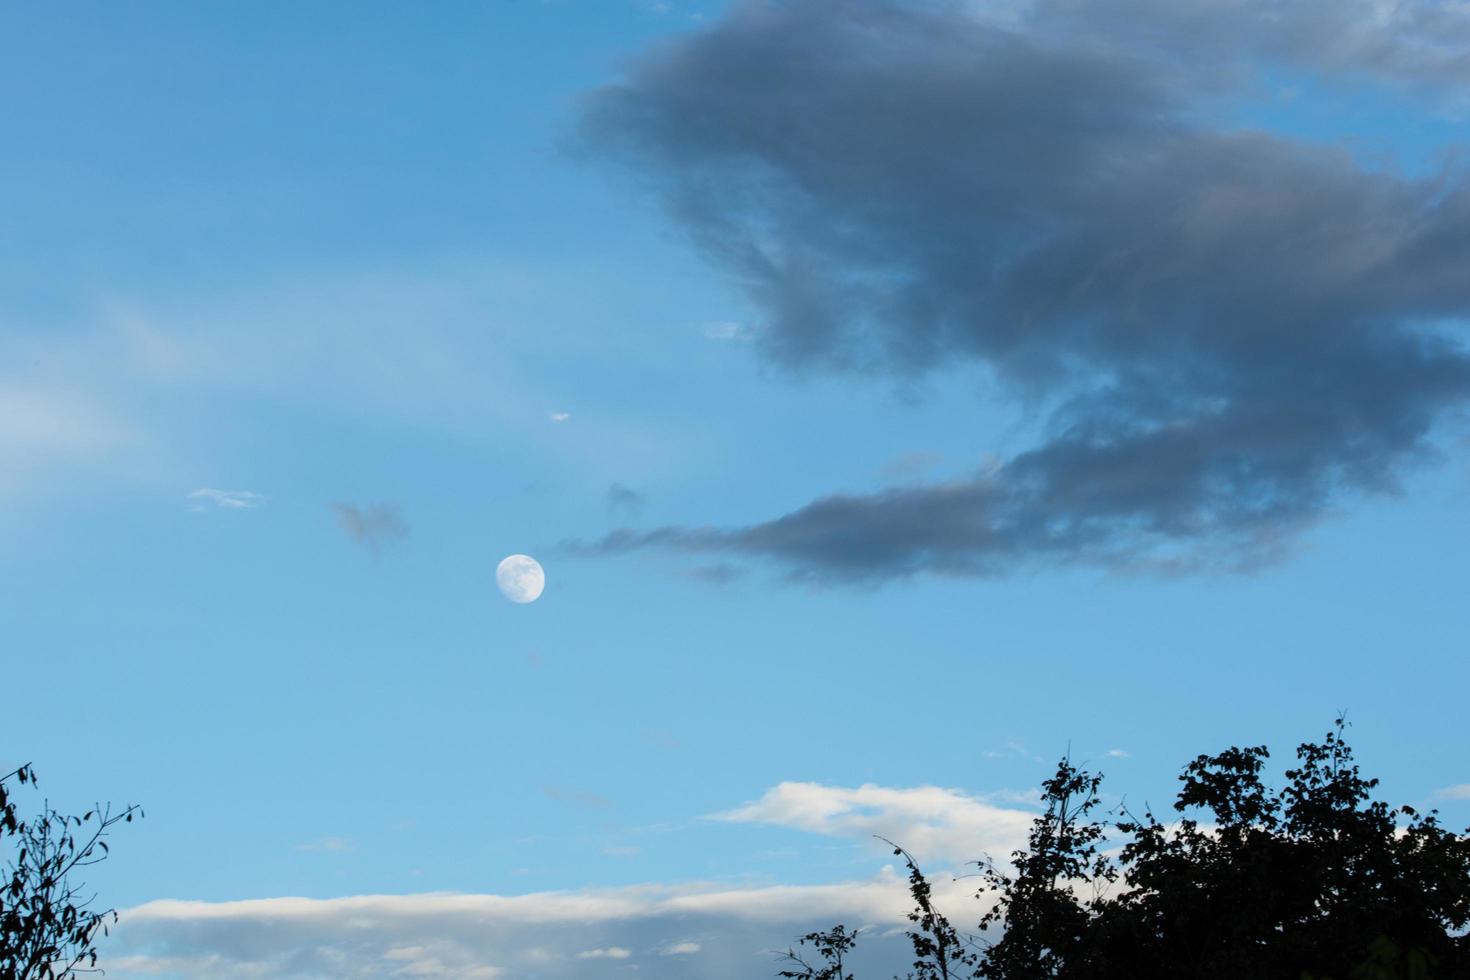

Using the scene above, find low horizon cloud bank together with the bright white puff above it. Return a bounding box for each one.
[103,782,1036,980]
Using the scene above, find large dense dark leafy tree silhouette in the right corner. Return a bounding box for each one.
[788,718,1470,980]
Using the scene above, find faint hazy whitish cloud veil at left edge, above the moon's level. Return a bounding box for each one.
[0,263,561,522]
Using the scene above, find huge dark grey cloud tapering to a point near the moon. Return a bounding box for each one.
[567,0,1470,582]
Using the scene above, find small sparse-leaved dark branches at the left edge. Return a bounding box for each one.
[0,765,143,980]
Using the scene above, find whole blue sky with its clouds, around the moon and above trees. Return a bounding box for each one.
[0,0,1470,977]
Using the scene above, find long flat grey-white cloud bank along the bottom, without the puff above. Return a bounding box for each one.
[100,868,929,980]
